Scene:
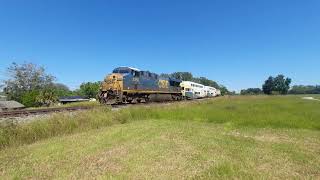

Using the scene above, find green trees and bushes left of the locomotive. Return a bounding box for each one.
[2,63,100,107]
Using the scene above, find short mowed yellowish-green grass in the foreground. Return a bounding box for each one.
[0,120,320,179]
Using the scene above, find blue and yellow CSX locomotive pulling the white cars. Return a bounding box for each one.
[98,67,182,104]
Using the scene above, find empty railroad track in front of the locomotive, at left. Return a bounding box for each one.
[0,106,93,118]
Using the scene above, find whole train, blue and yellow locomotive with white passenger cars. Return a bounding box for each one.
[98,67,220,105]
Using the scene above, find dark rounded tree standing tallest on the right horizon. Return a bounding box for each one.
[262,74,291,94]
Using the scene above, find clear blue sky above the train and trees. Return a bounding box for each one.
[0,0,320,91]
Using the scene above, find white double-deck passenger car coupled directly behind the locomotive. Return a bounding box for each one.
[180,81,207,99]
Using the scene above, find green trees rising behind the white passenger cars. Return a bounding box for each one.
[160,72,233,95]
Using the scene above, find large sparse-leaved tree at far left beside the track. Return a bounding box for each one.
[4,63,55,107]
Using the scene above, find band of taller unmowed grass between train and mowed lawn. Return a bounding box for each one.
[0,96,320,148]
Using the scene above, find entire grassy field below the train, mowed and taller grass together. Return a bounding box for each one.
[0,96,320,179]
